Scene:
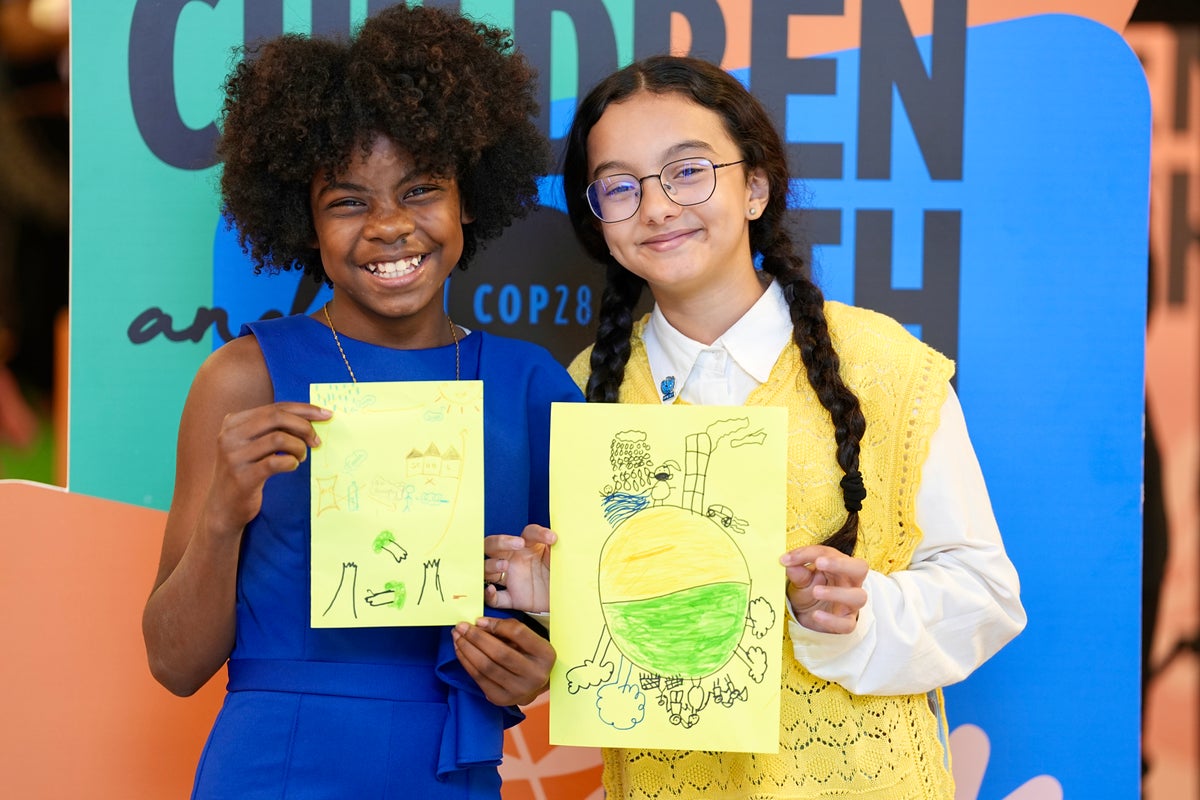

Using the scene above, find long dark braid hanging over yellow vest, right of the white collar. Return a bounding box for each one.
[763,245,866,555]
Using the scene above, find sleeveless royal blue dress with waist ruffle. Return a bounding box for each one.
[192,315,582,800]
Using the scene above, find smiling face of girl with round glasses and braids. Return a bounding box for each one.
[587,91,767,321]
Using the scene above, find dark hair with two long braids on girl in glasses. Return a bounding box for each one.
[563,55,866,555]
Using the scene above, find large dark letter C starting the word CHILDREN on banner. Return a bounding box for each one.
[128,0,223,169]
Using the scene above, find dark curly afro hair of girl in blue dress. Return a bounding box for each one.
[217,4,548,283]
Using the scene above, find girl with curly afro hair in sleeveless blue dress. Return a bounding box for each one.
[143,5,580,800]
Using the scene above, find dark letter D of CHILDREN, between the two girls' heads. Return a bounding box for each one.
[512,0,617,151]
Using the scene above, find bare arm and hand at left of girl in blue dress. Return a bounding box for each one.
[142,337,329,696]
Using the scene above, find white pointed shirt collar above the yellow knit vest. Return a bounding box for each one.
[643,281,792,403]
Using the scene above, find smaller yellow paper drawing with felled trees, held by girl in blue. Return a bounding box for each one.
[310,380,484,627]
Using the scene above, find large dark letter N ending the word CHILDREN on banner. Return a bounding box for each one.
[858,0,967,181]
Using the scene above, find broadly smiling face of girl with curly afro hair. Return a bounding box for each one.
[310,137,470,348]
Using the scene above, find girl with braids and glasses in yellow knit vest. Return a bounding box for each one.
[563,56,1025,800]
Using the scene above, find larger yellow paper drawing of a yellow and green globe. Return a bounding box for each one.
[551,403,787,752]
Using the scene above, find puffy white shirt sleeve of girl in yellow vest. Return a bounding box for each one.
[788,389,1026,694]
